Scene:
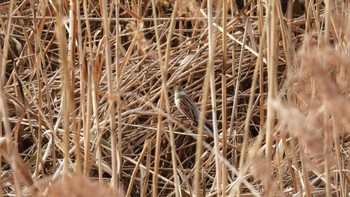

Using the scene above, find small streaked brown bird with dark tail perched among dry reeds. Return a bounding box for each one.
[175,85,213,137]
